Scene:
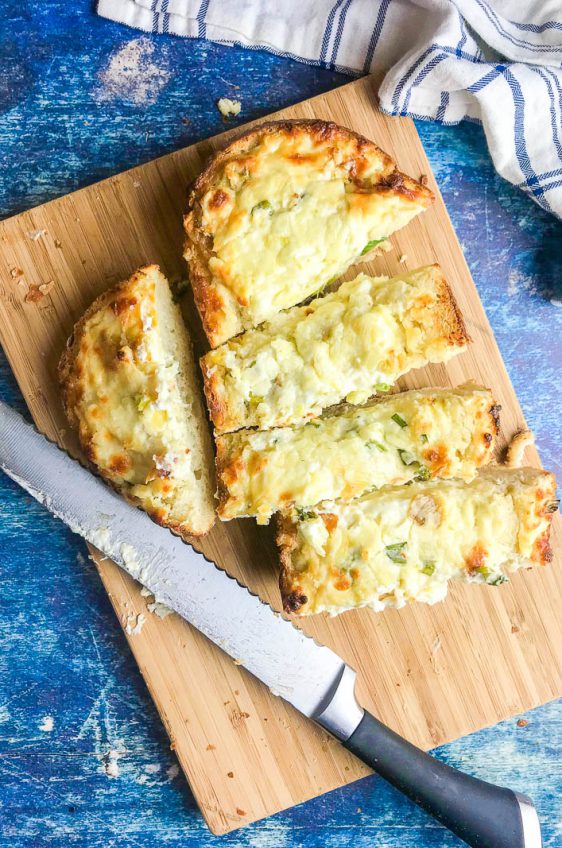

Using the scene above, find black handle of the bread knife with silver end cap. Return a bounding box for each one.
[343,712,542,848]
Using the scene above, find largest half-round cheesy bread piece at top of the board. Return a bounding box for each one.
[184,120,434,347]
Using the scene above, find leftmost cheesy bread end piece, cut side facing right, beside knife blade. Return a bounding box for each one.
[59,265,215,535]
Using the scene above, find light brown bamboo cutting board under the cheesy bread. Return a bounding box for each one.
[0,79,562,834]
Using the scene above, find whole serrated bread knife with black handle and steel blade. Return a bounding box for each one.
[0,401,542,848]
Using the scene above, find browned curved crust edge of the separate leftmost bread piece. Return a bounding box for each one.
[57,264,213,539]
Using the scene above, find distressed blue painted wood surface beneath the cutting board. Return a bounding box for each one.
[0,0,562,848]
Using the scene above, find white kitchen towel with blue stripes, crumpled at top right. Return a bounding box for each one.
[97,0,562,218]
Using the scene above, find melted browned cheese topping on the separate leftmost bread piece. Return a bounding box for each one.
[67,272,207,524]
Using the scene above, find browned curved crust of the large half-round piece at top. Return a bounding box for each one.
[184,119,434,347]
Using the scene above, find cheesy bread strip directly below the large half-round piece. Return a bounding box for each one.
[201,265,470,433]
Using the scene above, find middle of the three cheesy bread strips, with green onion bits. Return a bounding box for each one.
[217,384,499,524]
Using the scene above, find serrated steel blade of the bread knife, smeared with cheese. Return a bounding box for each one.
[0,403,344,716]
